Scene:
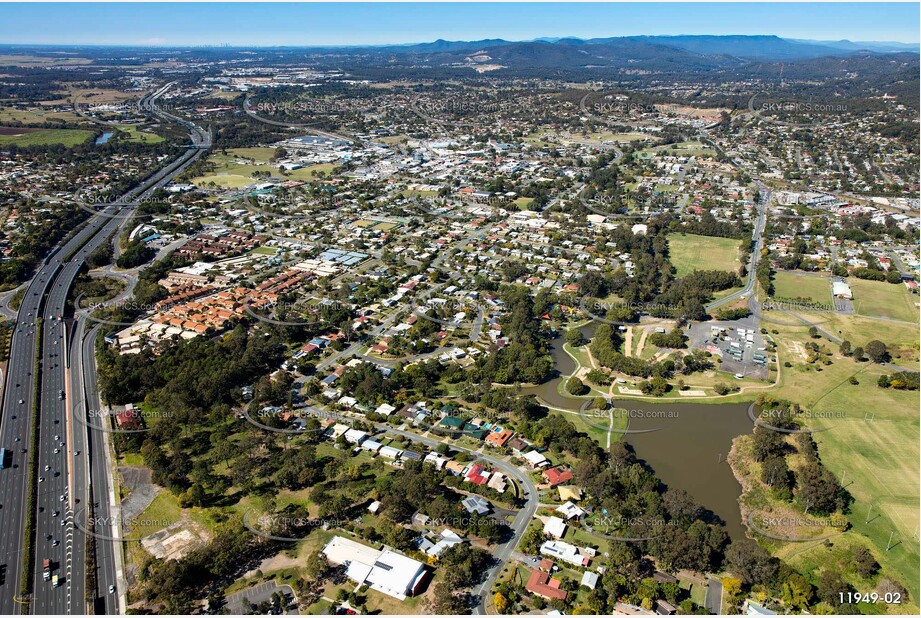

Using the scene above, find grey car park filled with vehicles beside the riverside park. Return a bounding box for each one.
[688,316,773,380]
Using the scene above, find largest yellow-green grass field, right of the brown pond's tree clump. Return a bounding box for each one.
[775,316,921,599]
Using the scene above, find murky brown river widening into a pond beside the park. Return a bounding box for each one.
[522,324,753,539]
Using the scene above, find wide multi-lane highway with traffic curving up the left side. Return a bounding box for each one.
[0,84,211,615]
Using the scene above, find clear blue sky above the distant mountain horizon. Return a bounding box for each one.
[0,2,921,46]
